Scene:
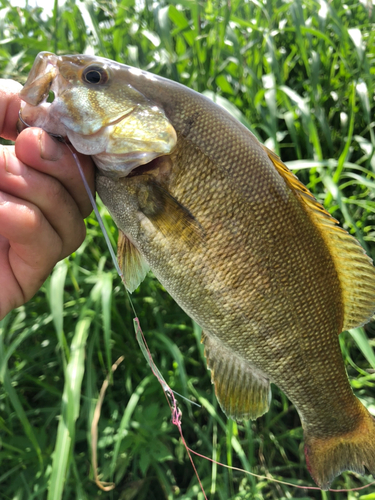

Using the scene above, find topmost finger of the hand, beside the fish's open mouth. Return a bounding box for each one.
[0,78,22,141]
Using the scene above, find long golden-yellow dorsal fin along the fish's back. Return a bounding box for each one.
[263,146,375,330]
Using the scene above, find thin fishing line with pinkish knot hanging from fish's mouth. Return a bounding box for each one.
[19,118,375,500]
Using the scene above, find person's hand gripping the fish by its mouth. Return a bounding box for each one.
[0,79,95,319]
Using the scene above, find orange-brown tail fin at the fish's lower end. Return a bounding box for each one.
[305,408,375,490]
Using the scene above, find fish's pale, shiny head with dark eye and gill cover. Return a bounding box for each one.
[20,52,177,178]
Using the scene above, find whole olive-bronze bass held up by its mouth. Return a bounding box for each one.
[20,52,375,490]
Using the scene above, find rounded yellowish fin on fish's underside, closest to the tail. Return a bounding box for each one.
[202,333,271,421]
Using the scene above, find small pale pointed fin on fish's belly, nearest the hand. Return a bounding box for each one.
[117,229,150,293]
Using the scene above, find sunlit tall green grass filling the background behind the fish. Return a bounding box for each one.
[0,0,375,500]
